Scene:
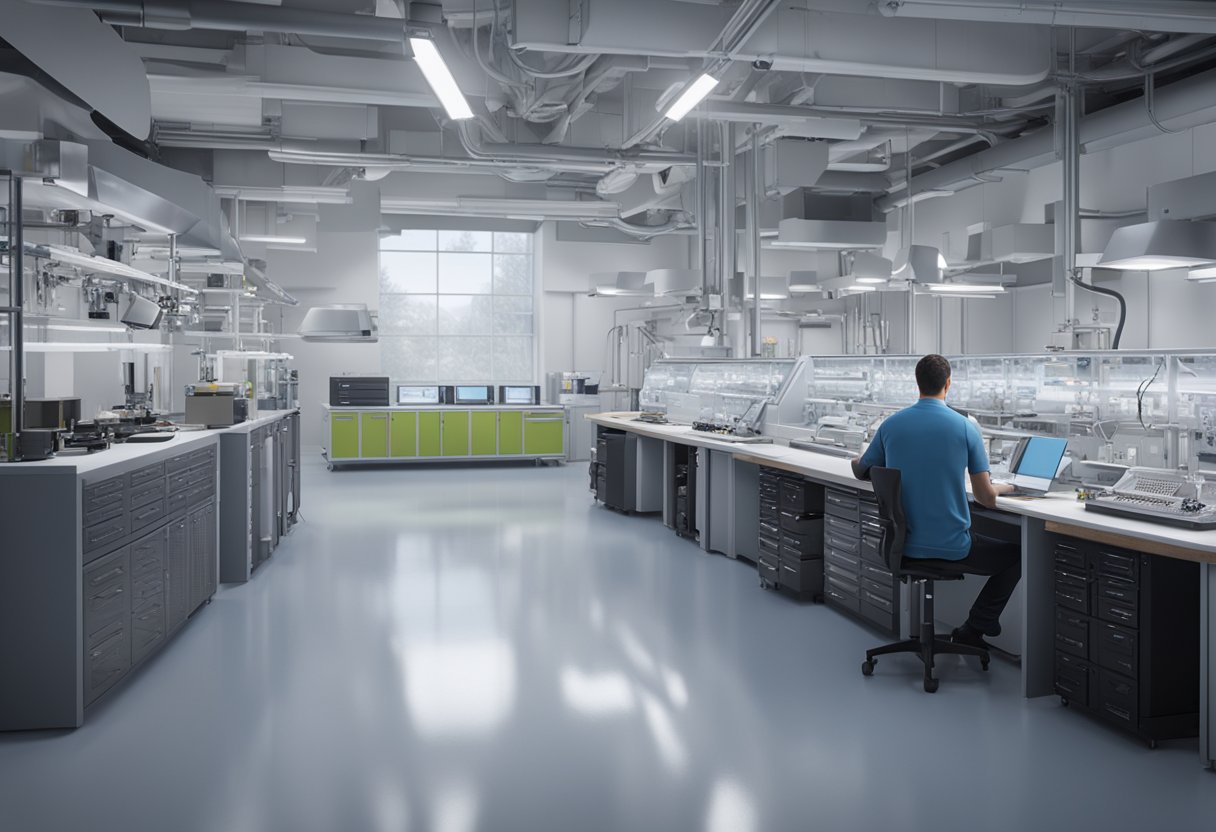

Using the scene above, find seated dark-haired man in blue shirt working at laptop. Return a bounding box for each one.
[854,355,1021,646]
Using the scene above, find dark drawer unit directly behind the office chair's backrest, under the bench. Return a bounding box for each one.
[823,488,900,634]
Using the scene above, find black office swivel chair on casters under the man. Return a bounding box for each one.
[861,468,990,693]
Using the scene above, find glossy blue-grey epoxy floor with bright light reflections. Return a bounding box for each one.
[0,462,1216,832]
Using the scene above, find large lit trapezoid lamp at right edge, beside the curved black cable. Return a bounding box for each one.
[1098,220,1216,271]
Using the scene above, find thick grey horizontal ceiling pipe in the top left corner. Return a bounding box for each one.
[32,0,405,42]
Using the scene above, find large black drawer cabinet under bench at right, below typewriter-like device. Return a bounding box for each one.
[1053,538,1199,746]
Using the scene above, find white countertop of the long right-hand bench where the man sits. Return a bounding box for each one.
[587,414,1216,553]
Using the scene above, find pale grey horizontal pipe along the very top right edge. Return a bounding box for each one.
[878,0,1216,34]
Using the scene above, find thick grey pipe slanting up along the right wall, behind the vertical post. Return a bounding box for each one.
[874,69,1216,212]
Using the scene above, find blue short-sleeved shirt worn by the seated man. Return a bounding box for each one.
[861,399,989,561]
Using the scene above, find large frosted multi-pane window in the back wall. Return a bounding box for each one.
[379,231,536,384]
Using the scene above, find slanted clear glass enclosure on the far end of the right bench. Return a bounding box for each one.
[638,359,795,426]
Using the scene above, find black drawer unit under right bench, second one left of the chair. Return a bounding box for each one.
[756,466,823,601]
